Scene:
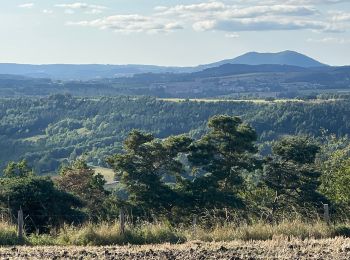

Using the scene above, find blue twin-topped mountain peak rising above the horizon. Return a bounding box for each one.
[201,51,327,68]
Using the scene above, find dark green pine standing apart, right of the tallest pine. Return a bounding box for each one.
[263,136,328,220]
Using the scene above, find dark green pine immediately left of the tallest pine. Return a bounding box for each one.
[108,130,192,219]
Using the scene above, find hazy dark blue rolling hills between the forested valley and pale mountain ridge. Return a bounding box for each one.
[0,64,350,98]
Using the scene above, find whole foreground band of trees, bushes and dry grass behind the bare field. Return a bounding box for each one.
[0,115,350,245]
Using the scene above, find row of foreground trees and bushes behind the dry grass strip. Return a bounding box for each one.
[0,115,350,232]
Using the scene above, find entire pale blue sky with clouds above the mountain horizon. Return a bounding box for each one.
[0,0,350,66]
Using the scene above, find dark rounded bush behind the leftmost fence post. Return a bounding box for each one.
[0,176,84,232]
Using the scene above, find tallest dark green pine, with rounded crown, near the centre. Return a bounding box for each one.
[184,115,257,217]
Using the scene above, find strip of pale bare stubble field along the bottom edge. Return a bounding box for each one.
[0,238,350,260]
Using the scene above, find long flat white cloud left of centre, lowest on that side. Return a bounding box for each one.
[67,14,183,33]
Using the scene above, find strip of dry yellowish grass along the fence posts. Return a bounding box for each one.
[0,220,350,246]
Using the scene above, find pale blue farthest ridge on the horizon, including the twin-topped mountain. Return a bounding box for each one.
[0,51,326,80]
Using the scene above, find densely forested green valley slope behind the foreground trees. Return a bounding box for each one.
[0,95,350,174]
